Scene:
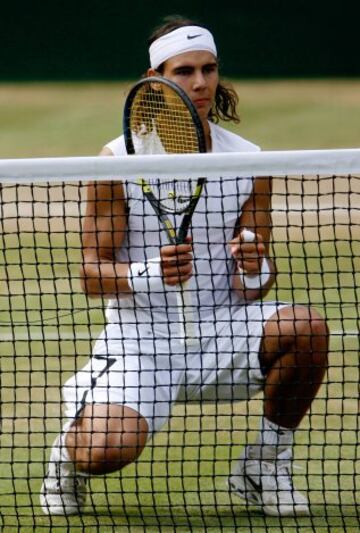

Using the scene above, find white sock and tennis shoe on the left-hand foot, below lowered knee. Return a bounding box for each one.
[40,435,87,515]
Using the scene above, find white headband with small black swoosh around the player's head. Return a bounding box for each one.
[149,26,217,69]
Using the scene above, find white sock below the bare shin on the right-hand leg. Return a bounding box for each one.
[249,416,294,459]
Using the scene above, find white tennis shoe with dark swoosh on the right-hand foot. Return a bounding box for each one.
[228,448,310,516]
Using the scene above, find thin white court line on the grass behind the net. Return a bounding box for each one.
[0,330,359,342]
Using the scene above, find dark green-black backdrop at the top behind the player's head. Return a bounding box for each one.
[0,0,360,81]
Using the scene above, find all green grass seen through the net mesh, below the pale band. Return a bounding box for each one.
[0,233,360,531]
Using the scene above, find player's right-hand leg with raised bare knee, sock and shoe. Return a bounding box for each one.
[229,307,328,516]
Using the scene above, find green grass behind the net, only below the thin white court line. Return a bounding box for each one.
[0,339,359,531]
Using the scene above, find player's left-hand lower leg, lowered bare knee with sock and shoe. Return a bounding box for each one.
[40,404,148,515]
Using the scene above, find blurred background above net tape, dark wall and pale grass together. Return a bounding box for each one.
[0,0,360,158]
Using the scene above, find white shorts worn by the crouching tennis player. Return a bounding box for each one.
[63,302,289,434]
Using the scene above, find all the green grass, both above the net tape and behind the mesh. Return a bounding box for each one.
[0,80,360,532]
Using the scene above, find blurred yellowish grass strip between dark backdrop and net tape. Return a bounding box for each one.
[0,80,360,158]
